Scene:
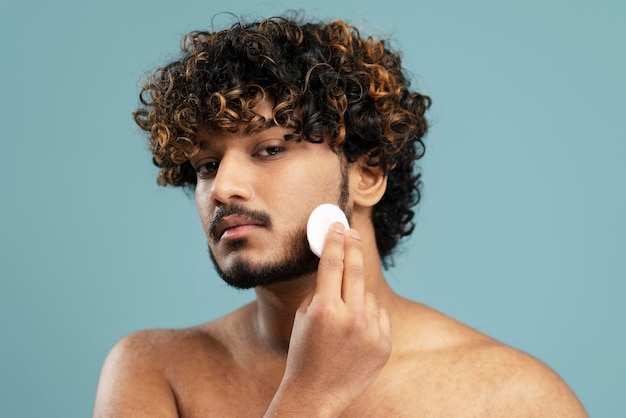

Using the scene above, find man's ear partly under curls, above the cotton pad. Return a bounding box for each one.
[350,156,387,207]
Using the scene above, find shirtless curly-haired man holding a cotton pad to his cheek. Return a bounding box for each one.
[94,13,586,417]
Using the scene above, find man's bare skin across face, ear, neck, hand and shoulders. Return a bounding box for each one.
[94,100,587,417]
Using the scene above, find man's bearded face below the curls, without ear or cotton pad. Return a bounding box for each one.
[192,107,349,289]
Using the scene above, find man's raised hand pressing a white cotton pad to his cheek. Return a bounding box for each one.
[268,223,391,416]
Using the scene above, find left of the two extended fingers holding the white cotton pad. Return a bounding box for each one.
[315,222,345,299]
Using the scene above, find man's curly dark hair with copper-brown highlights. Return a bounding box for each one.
[133,16,431,268]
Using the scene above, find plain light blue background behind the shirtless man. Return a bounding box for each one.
[0,0,626,418]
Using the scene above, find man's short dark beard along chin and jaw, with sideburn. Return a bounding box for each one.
[209,158,352,289]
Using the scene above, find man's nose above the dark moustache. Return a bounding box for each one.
[211,152,254,206]
